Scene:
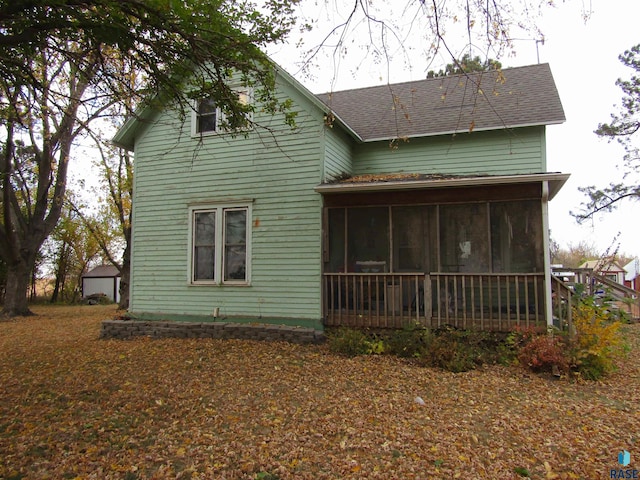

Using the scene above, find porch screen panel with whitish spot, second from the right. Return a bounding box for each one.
[440,203,490,273]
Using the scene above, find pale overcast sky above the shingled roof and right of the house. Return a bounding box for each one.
[270,0,640,255]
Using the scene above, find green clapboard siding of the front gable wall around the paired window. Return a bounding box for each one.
[130,79,324,328]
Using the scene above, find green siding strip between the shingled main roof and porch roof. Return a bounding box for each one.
[353,127,546,175]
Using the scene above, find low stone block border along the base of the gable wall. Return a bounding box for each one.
[100,320,324,343]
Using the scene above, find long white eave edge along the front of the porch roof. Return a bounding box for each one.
[314,173,570,200]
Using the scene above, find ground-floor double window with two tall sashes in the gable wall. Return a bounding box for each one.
[189,205,251,285]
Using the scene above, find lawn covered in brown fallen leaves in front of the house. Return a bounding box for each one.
[0,306,640,479]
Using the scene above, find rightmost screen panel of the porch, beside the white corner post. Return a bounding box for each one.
[491,200,544,273]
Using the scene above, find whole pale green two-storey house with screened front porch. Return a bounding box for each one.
[114,65,568,336]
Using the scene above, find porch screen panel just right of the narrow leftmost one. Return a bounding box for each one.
[347,207,389,272]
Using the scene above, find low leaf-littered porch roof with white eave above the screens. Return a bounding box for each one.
[315,173,570,200]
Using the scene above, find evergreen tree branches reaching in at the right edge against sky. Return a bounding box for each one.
[575,44,640,222]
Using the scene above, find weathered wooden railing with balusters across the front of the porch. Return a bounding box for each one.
[324,273,546,330]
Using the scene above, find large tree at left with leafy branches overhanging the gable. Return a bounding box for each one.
[0,0,297,316]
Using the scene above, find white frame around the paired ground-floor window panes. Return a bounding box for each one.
[188,203,253,286]
